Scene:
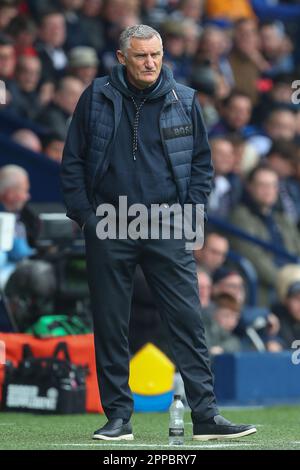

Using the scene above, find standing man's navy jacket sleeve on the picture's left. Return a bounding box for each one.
[60,86,94,227]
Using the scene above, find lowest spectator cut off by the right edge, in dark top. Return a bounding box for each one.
[273,265,300,349]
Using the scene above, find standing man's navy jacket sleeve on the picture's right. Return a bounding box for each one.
[186,93,213,222]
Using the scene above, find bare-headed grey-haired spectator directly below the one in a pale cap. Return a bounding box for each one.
[36,76,85,138]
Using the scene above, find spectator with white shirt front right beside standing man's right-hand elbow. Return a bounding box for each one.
[208,137,241,218]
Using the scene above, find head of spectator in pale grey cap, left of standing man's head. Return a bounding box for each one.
[69,46,99,86]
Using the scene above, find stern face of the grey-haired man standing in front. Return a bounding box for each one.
[117,36,163,89]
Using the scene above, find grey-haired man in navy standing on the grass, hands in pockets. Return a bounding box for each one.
[61,25,256,440]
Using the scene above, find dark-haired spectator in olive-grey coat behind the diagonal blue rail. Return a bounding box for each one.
[230,165,300,306]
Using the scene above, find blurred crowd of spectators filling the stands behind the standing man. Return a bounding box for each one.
[0,0,300,354]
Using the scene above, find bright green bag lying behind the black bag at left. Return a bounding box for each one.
[25,315,91,338]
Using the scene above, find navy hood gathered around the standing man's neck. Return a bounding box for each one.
[110,64,175,100]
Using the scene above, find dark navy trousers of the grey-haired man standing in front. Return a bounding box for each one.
[84,216,218,421]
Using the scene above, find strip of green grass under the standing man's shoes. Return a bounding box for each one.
[0,406,300,450]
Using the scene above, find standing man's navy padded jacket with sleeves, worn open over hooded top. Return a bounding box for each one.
[61,65,213,226]
